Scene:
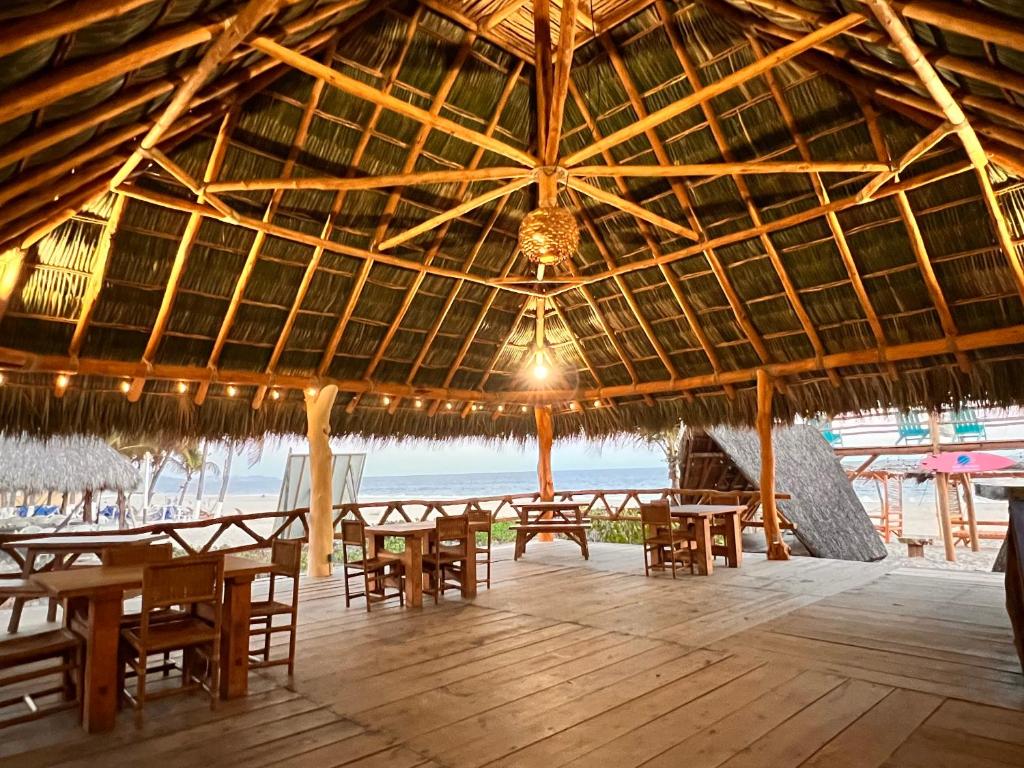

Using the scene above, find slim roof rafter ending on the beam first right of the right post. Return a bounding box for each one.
[655,6,840,387]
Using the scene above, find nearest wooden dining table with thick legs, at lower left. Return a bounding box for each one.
[32,555,272,733]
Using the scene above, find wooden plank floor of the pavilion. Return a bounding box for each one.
[0,542,1024,768]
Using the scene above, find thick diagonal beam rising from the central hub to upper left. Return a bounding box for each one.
[251,37,537,168]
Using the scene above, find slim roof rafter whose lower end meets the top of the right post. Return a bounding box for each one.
[598,34,770,370]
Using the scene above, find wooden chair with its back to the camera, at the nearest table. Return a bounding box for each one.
[121,555,224,726]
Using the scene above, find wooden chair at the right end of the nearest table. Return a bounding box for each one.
[249,539,302,677]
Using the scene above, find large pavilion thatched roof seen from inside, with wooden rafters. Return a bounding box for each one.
[0,0,1024,437]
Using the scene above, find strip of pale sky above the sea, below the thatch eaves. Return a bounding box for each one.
[210,438,664,477]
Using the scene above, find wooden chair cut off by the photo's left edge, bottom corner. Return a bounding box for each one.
[0,630,83,728]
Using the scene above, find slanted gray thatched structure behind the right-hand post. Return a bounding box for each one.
[708,425,887,561]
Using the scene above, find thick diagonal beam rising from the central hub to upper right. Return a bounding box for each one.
[561,13,864,167]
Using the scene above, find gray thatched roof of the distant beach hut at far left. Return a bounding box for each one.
[0,434,139,494]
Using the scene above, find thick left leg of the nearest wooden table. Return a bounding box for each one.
[82,591,123,733]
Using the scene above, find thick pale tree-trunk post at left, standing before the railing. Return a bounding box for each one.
[305,384,338,577]
